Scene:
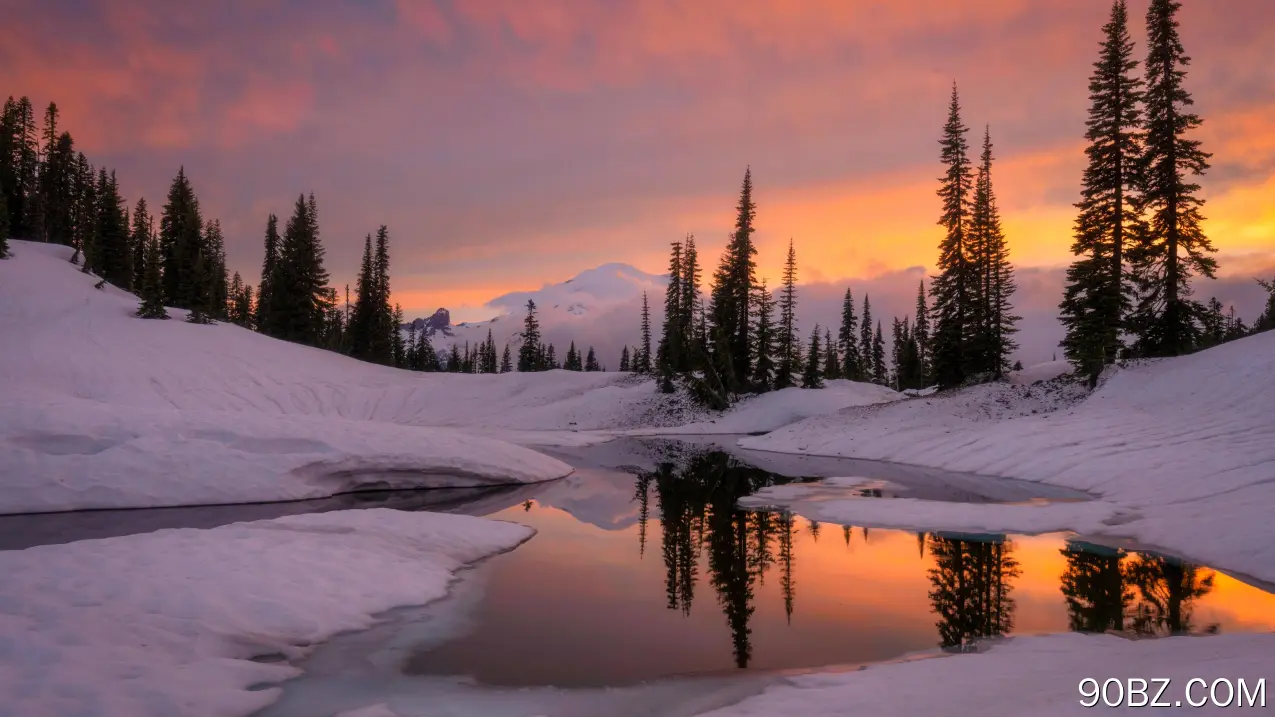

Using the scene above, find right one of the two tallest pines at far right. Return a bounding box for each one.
[1130,0,1218,356]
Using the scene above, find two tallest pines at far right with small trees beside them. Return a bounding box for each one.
[1060,0,1275,381]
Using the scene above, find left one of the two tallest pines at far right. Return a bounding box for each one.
[1060,0,1142,383]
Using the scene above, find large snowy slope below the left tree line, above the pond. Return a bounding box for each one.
[0,242,578,513]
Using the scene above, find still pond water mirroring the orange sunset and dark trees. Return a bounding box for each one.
[403,450,1275,688]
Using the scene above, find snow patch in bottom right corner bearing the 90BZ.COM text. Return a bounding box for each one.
[701,634,1275,717]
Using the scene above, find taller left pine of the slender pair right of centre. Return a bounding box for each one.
[929,83,978,387]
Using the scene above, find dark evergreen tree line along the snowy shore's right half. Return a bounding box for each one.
[631,0,1275,408]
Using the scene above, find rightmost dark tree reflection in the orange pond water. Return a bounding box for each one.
[1061,541,1216,635]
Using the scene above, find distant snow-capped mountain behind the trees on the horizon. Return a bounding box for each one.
[403,263,668,369]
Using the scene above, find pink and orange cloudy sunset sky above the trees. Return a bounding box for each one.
[0,0,1275,329]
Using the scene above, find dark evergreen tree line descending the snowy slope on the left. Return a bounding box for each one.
[0,97,603,374]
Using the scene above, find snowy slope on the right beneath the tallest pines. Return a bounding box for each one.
[740,332,1275,582]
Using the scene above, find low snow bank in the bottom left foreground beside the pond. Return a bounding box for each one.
[0,509,533,717]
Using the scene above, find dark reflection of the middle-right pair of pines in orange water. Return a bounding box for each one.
[929,533,1020,648]
